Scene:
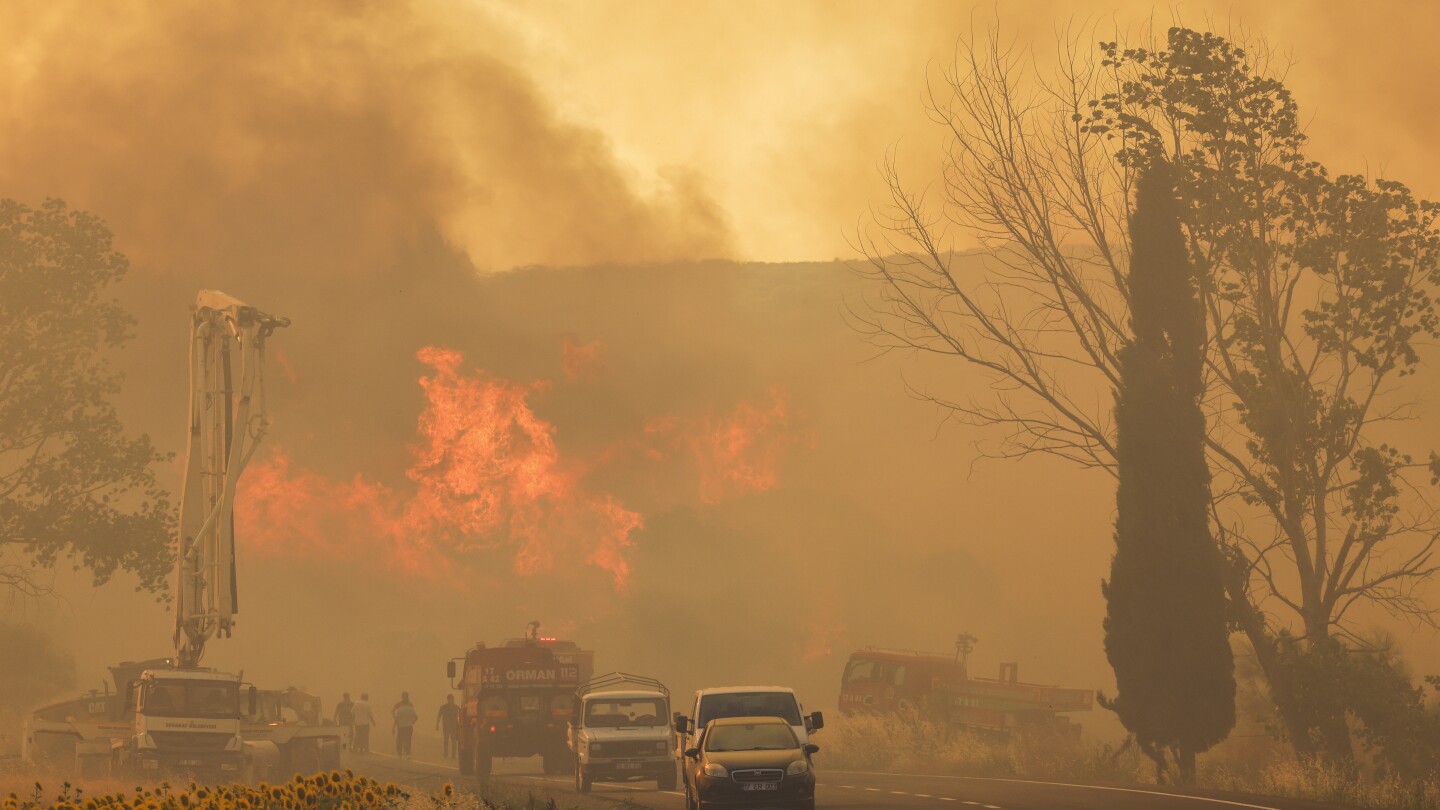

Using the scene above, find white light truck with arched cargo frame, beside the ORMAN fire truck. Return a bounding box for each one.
[567,673,678,793]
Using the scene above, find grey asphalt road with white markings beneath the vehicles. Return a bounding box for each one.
[350,752,1336,810]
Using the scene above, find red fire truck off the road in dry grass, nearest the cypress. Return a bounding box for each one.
[840,640,1094,738]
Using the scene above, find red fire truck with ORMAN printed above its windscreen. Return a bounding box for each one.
[446,623,595,780]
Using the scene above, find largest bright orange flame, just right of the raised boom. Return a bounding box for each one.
[236,347,642,588]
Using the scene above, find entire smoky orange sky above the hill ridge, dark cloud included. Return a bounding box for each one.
[0,0,1440,271]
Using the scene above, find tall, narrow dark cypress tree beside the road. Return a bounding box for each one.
[1102,164,1236,781]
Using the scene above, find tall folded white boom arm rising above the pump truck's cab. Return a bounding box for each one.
[174,290,289,667]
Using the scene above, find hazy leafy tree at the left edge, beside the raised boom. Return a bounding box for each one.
[0,200,173,591]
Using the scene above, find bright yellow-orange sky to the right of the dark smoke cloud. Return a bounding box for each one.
[486,0,1440,261]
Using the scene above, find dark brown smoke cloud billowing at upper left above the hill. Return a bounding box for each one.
[0,0,729,275]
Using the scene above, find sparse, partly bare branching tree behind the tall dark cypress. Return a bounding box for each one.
[858,27,1440,760]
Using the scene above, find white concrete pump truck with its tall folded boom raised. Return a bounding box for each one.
[114,290,289,778]
